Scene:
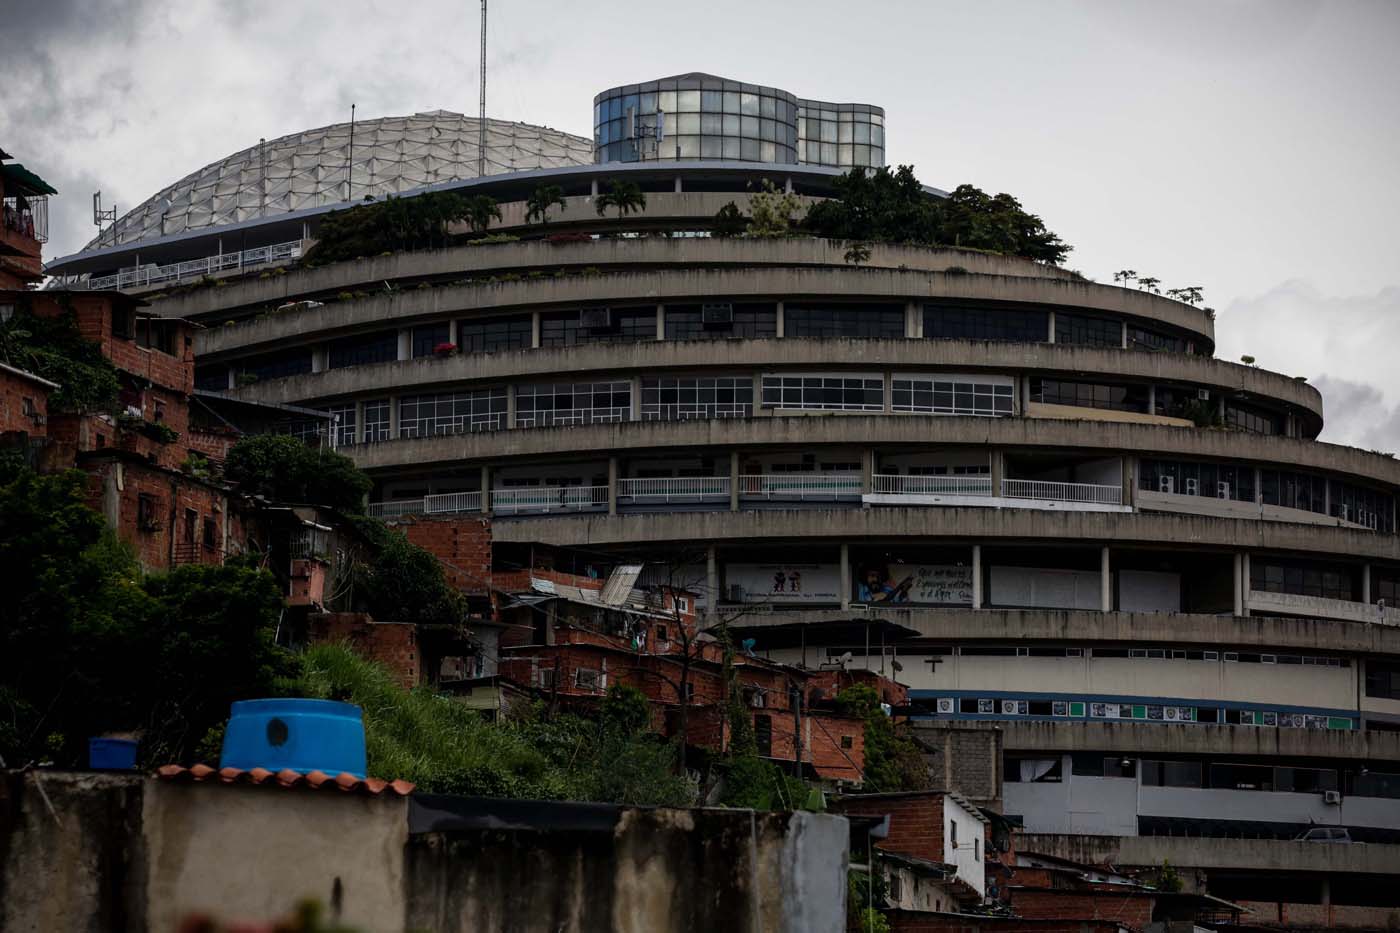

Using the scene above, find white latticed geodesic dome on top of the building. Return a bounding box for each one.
[84,111,594,249]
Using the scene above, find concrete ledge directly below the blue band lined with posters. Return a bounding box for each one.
[916,721,1400,762]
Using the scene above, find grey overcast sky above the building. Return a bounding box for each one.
[0,0,1400,451]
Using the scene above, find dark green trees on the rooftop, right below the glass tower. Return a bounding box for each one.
[806,165,1070,263]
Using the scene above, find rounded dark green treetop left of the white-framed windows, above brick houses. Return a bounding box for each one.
[224,434,372,513]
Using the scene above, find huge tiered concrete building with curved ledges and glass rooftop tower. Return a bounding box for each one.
[49,76,1400,909]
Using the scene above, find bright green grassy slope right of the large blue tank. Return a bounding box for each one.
[287,644,693,806]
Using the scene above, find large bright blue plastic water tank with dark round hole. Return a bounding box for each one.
[218,699,365,778]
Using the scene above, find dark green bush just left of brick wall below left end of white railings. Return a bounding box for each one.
[347,516,466,625]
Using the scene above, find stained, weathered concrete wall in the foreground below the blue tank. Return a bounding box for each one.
[0,770,848,933]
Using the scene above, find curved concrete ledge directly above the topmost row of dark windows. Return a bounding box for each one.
[194,264,1214,357]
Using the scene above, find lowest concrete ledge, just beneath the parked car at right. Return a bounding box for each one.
[1016,834,1400,874]
